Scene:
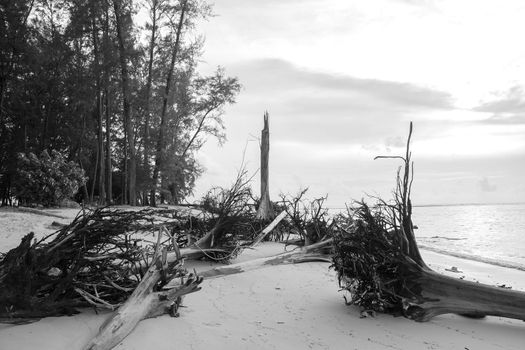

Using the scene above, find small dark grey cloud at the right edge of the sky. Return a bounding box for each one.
[474,86,525,125]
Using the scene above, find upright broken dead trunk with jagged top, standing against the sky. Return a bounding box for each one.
[257,112,273,220]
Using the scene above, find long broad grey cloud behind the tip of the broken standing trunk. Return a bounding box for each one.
[221,58,454,149]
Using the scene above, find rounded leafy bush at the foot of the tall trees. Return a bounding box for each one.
[13,150,86,207]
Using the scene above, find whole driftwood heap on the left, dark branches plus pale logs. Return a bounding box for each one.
[0,172,331,350]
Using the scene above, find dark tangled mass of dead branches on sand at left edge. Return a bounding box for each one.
[0,208,203,323]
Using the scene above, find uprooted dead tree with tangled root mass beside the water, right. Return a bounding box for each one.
[333,124,525,321]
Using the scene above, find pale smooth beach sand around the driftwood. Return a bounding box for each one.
[0,212,525,350]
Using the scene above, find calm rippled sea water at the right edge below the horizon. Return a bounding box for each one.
[412,204,525,270]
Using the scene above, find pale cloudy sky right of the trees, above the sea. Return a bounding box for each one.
[190,0,525,208]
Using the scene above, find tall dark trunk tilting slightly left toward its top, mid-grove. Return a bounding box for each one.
[113,0,136,205]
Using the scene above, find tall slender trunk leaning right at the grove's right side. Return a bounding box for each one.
[150,0,187,206]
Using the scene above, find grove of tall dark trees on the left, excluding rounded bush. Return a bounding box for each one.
[0,0,240,205]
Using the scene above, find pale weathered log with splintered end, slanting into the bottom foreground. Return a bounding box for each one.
[84,243,203,350]
